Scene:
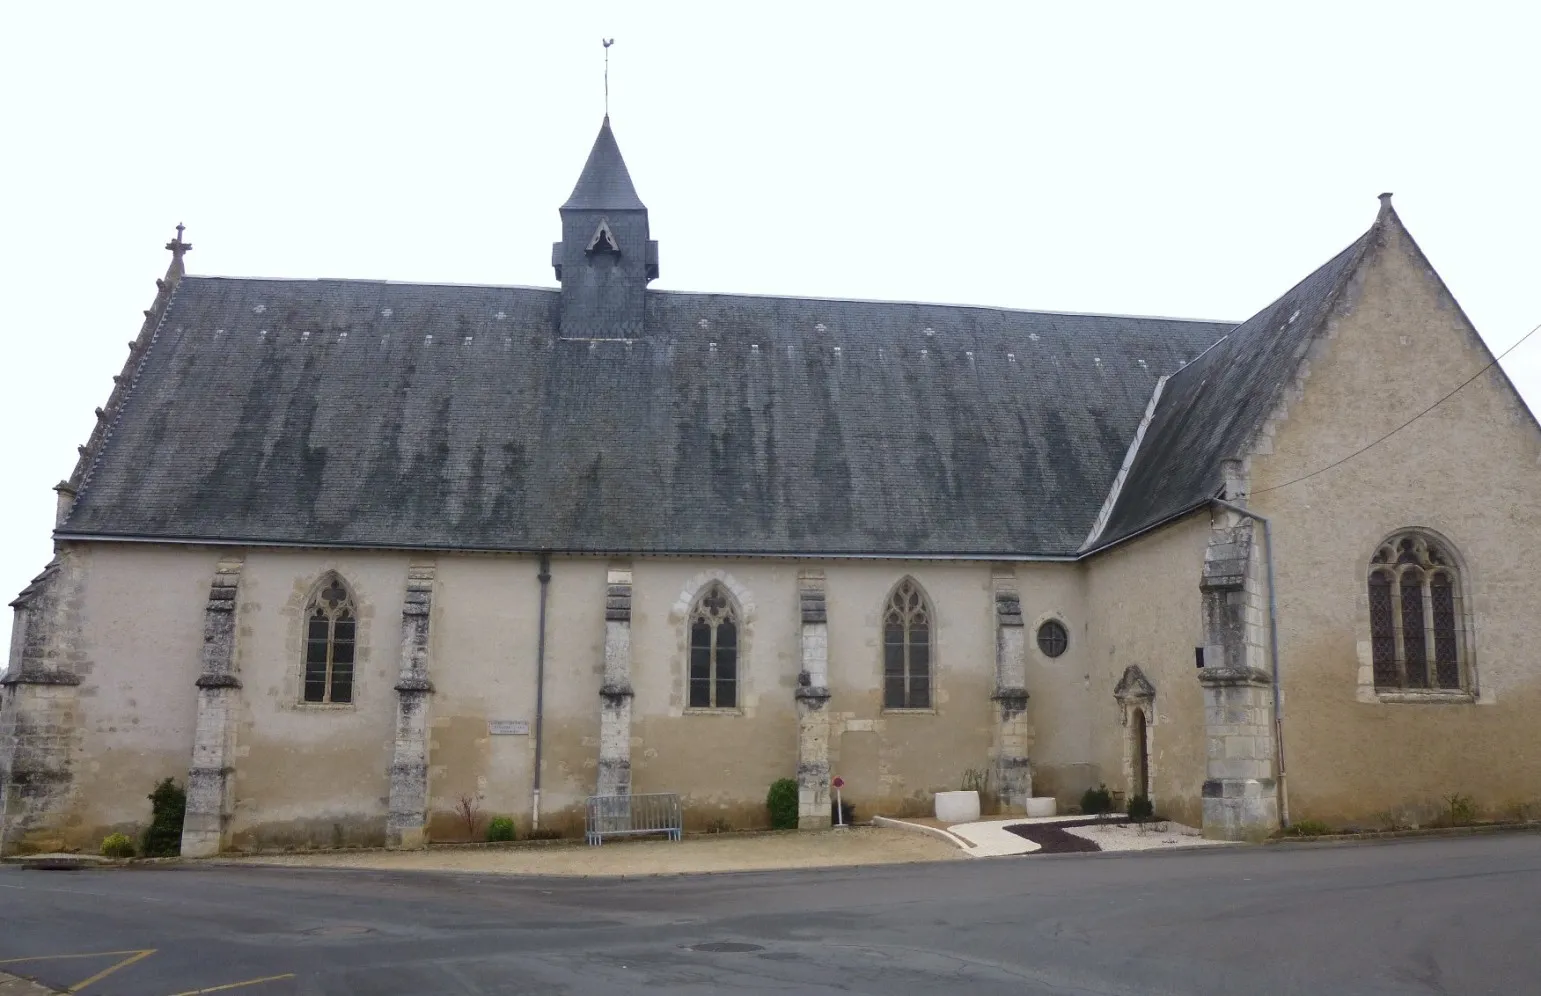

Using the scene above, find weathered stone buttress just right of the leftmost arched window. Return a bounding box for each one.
[385,561,436,850]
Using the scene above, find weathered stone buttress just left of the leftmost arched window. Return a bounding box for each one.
[182,558,242,857]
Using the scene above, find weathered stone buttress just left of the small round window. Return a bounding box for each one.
[991,569,1032,813]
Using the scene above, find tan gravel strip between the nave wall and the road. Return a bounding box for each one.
[224,826,965,876]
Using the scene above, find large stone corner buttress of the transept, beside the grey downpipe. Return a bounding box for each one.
[1199,492,1279,840]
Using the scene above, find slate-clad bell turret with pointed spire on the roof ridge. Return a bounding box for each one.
[552,114,658,339]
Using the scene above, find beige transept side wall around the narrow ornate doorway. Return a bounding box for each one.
[1084,512,1210,826]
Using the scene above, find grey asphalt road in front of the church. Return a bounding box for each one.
[0,834,1541,996]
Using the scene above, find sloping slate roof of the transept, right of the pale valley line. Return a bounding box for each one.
[1089,229,1390,549]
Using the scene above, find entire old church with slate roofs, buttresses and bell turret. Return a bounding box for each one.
[0,119,1541,854]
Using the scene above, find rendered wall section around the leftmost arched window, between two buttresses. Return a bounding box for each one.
[224,550,408,850]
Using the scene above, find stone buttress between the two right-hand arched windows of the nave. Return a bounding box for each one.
[797,570,831,829]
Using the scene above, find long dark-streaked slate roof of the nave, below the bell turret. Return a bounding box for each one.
[59,280,1232,557]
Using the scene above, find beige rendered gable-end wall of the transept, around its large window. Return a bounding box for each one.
[1250,219,1541,825]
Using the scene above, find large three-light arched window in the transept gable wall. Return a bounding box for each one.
[1368,530,1470,691]
